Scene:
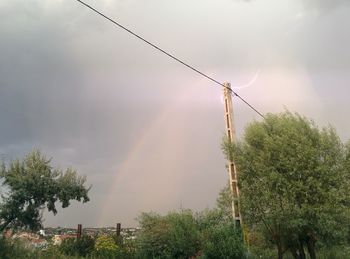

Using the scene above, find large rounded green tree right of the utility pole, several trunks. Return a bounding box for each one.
[223,112,349,258]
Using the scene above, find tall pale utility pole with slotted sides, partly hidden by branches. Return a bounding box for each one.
[223,82,242,226]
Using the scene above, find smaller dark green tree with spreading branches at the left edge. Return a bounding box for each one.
[0,150,90,231]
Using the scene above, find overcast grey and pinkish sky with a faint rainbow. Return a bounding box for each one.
[0,0,350,227]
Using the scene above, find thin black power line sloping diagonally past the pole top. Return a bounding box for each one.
[76,0,265,119]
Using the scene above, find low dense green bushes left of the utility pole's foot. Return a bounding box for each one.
[138,209,246,259]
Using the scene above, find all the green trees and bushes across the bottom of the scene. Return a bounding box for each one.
[0,112,350,259]
